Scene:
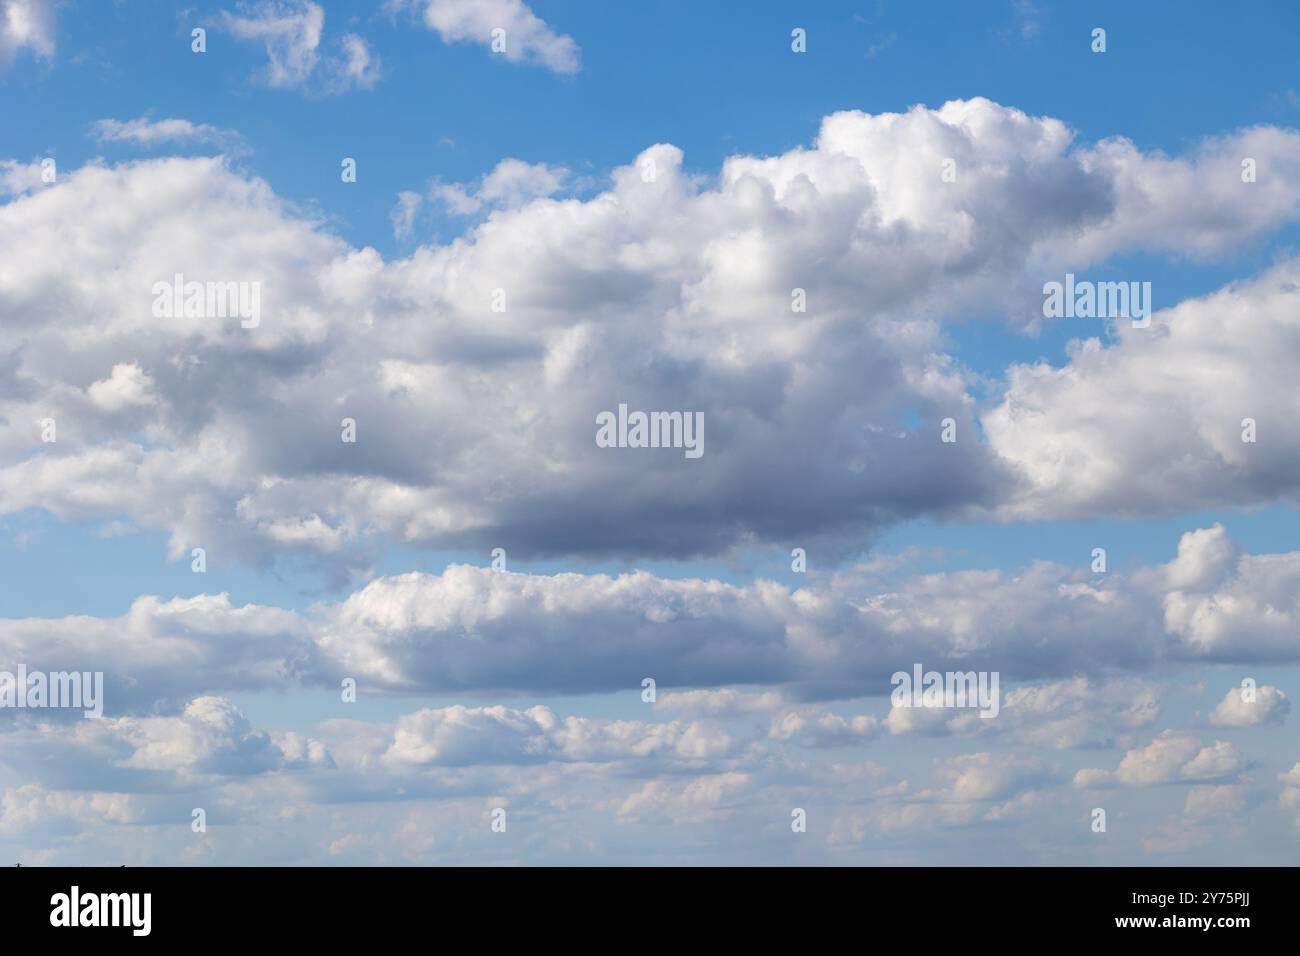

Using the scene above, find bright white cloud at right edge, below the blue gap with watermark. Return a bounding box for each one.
[982,257,1300,518]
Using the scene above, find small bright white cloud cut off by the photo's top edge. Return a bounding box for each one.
[389,0,581,74]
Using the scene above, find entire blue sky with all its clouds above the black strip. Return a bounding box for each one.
[0,0,1300,864]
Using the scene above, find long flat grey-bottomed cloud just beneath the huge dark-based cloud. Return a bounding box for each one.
[316,554,1193,697]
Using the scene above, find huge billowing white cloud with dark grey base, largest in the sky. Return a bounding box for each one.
[0,102,1300,581]
